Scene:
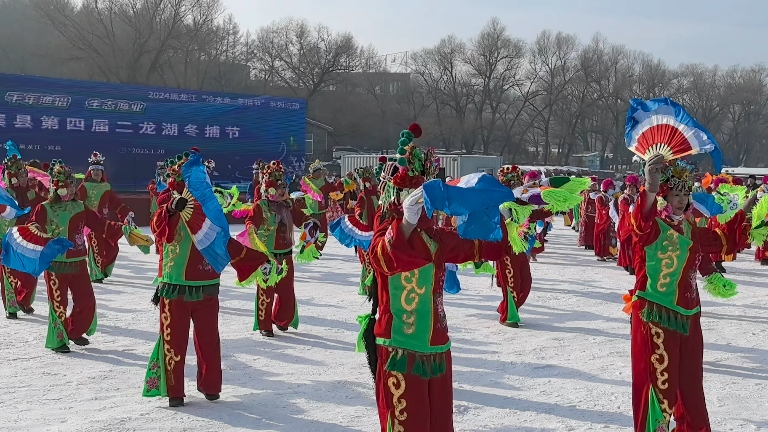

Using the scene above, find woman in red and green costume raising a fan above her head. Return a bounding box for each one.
[630,155,755,432]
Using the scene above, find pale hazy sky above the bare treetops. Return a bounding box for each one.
[223,0,768,66]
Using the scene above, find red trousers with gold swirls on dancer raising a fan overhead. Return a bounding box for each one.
[632,300,711,432]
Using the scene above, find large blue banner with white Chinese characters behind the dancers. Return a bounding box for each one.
[0,74,306,190]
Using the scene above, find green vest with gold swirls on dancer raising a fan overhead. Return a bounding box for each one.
[637,218,701,316]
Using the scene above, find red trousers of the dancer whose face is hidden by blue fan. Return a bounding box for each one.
[160,296,221,398]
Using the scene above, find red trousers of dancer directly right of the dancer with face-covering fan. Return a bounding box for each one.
[253,254,298,331]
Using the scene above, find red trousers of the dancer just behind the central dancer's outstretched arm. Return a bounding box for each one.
[496,253,533,323]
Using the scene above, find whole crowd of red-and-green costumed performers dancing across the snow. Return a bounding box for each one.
[0,124,768,432]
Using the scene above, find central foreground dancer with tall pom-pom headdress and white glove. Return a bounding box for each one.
[363,124,509,432]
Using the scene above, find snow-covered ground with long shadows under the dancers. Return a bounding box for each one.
[0,220,768,432]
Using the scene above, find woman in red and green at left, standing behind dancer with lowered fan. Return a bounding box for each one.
[77,152,133,283]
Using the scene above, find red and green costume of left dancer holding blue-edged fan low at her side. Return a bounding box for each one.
[29,201,123,349]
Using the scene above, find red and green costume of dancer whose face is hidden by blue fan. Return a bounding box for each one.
[143,182,269,398]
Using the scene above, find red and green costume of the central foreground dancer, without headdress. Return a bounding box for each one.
[370,213,509,432]
